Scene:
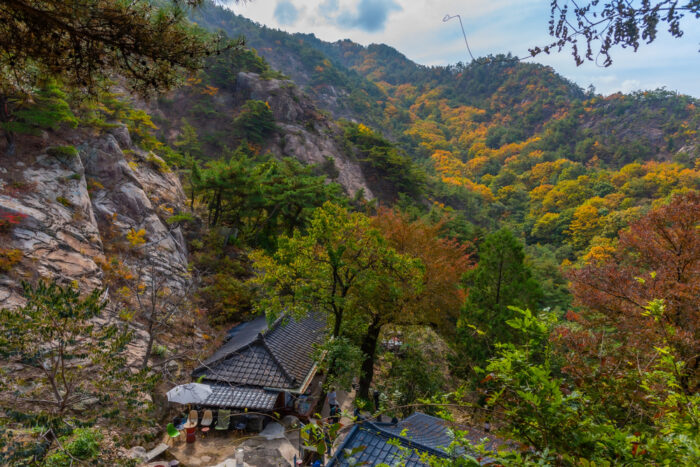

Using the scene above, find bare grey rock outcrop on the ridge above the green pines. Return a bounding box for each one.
[150,72,375,199]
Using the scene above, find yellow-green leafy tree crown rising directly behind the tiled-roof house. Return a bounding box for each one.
[253,202,416,337]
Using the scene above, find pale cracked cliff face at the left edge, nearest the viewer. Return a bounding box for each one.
[0,127,189,307]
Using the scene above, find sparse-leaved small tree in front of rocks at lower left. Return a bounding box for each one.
[0,283,130,413]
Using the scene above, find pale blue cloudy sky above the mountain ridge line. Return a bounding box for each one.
[221,0,700,97]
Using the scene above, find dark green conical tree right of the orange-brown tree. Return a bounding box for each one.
[459,229,542,372]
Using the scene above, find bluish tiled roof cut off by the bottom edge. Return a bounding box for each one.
[327,412,513,467]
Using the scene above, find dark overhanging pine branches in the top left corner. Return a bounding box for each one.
[0,0,228,95]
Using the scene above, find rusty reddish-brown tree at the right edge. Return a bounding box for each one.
[569,191,700,393]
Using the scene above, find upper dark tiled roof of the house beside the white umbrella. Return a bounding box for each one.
[193,315,325,389]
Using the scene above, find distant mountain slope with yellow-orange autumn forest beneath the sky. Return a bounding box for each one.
[189,0,700,261]
